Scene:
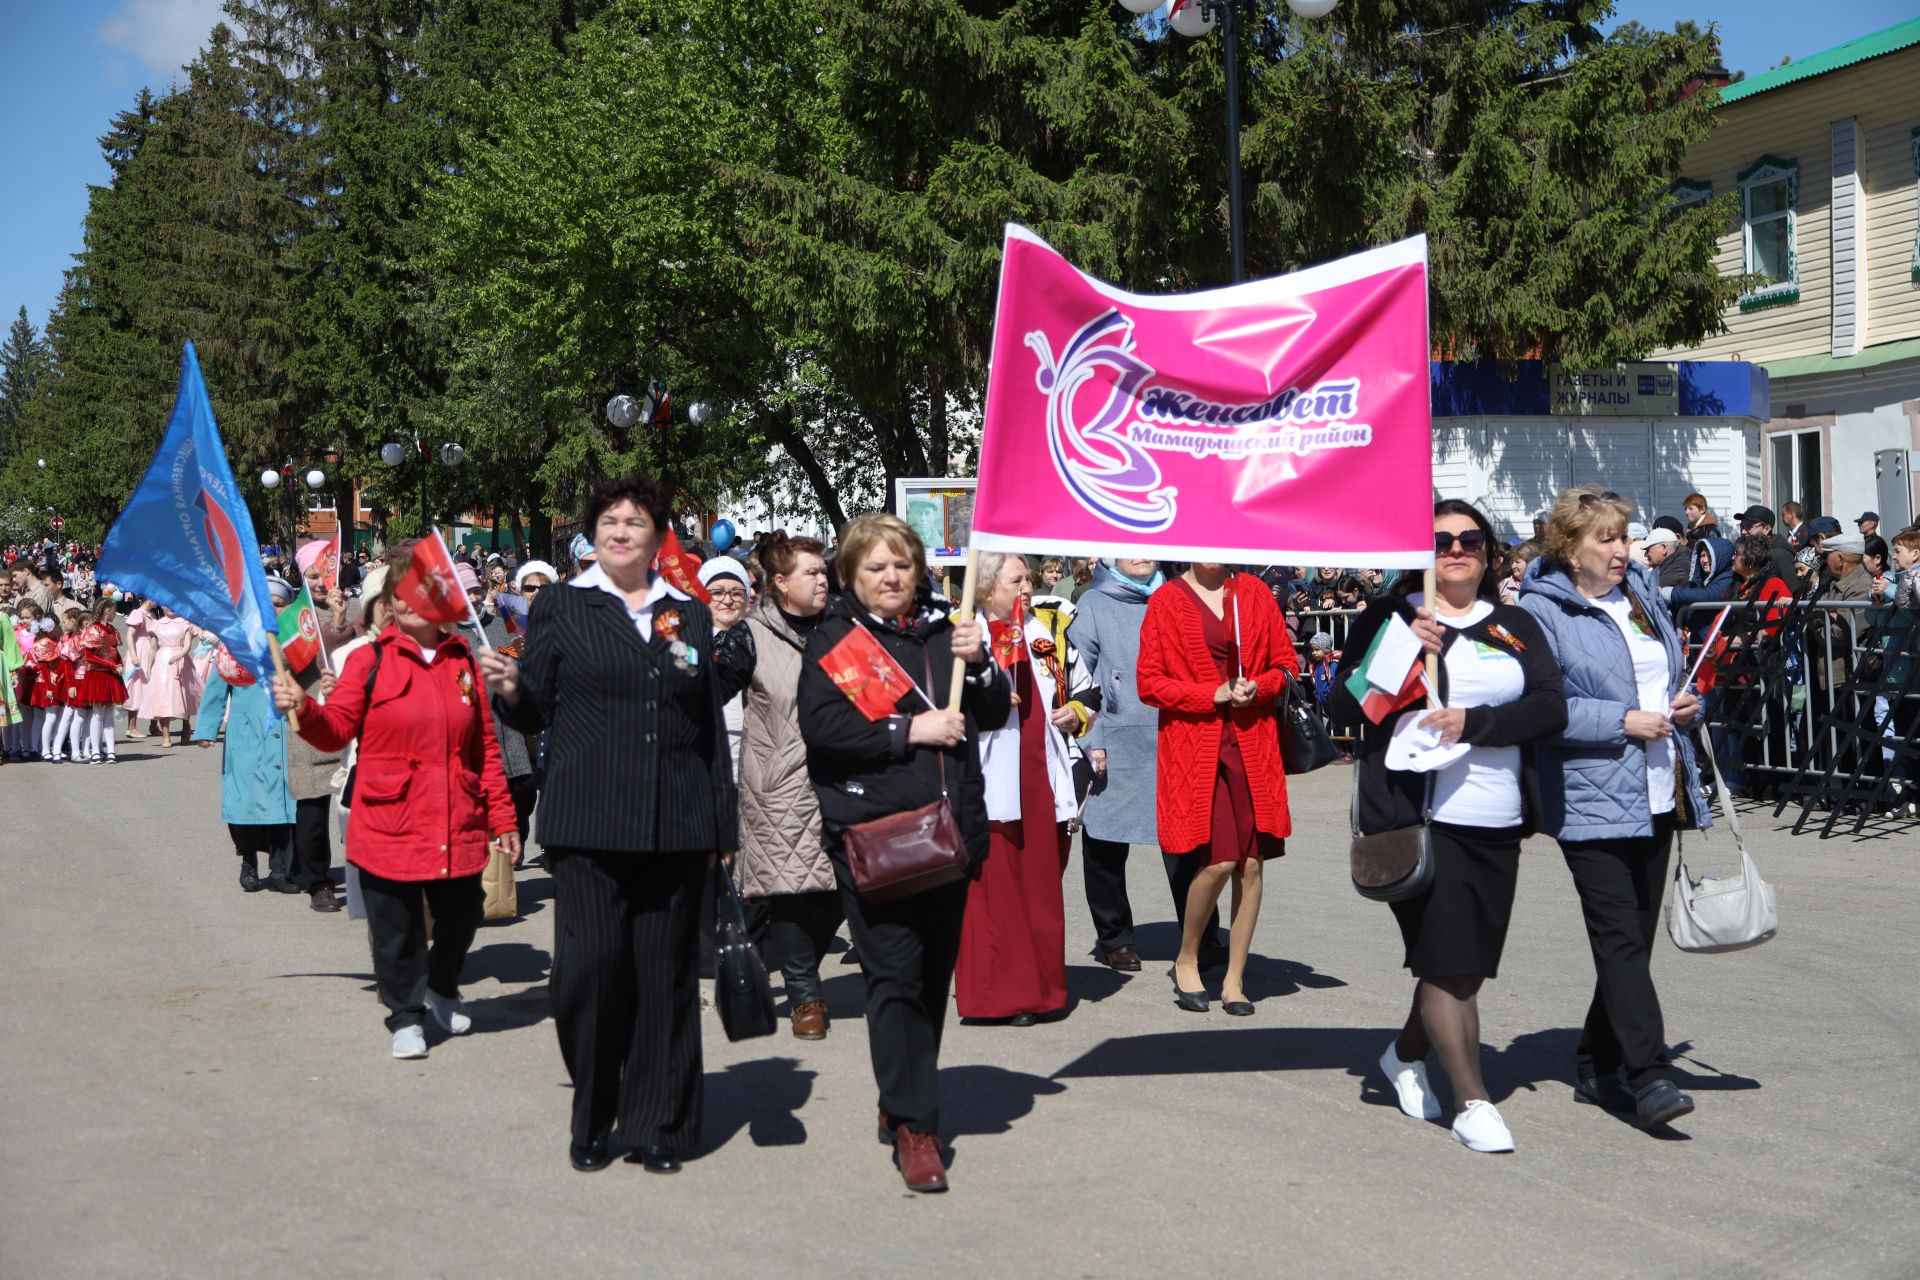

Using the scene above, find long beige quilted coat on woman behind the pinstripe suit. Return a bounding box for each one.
[735,599,833,898]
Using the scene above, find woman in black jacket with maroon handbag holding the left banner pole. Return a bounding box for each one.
[801,514,1012,1192]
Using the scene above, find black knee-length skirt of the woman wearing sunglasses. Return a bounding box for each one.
[1392,821,1521,979]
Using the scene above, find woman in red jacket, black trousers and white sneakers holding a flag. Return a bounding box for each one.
[273,547,520,1057]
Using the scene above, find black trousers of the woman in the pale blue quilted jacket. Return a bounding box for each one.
[1561,814,1674,1088]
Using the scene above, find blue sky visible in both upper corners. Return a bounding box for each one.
[0,0,1914,337]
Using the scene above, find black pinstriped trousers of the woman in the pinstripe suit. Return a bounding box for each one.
[547,846,712,1150]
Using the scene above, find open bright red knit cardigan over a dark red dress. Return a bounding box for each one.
[1137,574,1300,852]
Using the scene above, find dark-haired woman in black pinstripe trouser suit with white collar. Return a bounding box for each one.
[480,476,753,1173]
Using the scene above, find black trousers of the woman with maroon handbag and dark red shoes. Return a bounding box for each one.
[828,833,970,1134]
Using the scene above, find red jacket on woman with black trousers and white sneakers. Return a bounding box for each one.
[300,626,518,881]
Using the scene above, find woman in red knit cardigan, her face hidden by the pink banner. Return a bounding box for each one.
[1139,564,1300,1017]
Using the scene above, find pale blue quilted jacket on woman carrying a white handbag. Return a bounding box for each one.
[1519,560,1713,841]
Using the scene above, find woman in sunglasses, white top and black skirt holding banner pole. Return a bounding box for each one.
[1329,499,1567,1151]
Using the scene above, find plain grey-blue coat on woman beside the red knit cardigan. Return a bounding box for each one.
[1068,562,1160,844]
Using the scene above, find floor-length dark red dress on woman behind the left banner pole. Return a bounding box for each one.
[954,647,1073,1017]
